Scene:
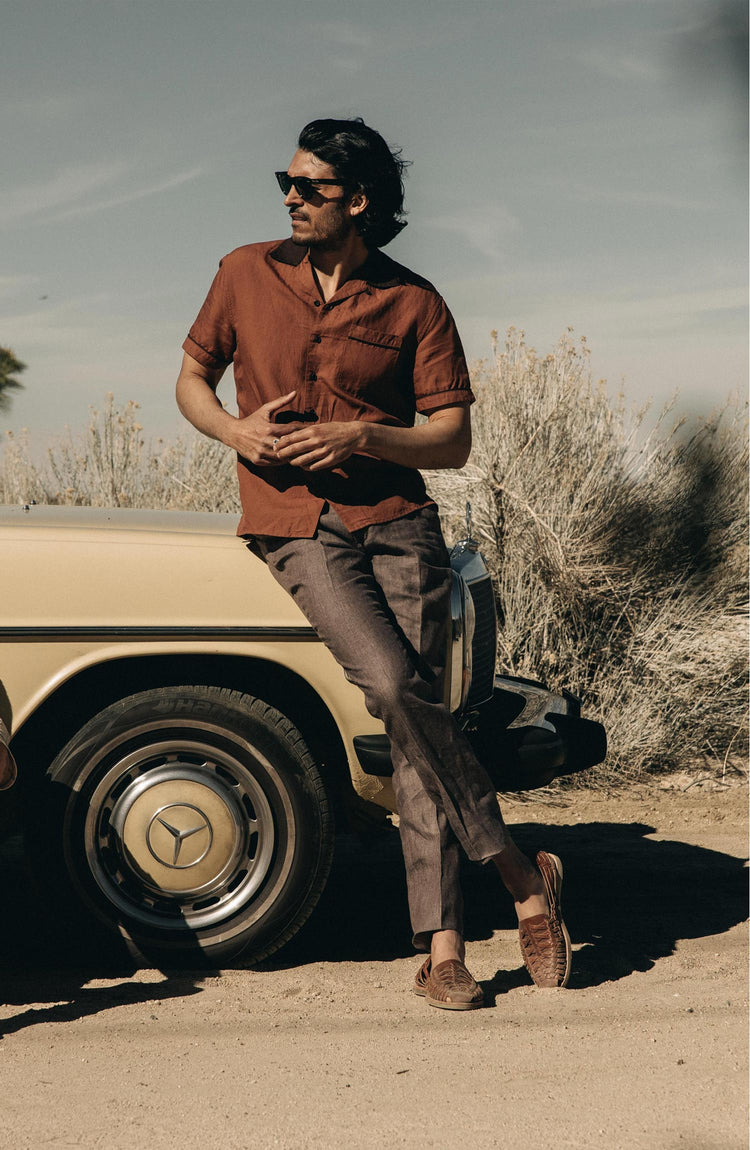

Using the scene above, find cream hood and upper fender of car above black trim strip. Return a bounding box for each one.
[0,505,306,637]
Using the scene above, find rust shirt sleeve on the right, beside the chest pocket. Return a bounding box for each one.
[414,296,475,414]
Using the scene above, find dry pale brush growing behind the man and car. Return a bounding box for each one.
[0,329,748,785]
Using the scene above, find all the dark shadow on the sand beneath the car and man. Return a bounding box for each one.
[0,822,747,1036]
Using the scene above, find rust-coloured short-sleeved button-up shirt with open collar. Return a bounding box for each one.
[183,239,474,538]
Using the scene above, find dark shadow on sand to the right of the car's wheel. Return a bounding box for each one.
[263,822,748,999]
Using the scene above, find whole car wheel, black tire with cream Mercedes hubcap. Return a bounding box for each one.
[32,687,334,968]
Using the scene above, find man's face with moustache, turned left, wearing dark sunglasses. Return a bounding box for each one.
[284,150,358,251]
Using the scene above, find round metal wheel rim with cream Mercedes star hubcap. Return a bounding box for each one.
[84,741,276,930]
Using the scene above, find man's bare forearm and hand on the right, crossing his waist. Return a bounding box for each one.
[275,405,472,472]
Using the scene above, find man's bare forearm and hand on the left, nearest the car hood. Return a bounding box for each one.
[177,352,304,467]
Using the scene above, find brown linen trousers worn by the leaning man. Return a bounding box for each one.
[251,506,507,950]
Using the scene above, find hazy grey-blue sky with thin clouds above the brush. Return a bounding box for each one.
[0,0,748,443]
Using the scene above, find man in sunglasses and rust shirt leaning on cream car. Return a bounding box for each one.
[177,112,571,1010]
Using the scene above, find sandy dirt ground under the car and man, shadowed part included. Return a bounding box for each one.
[0,785,748,1150]
